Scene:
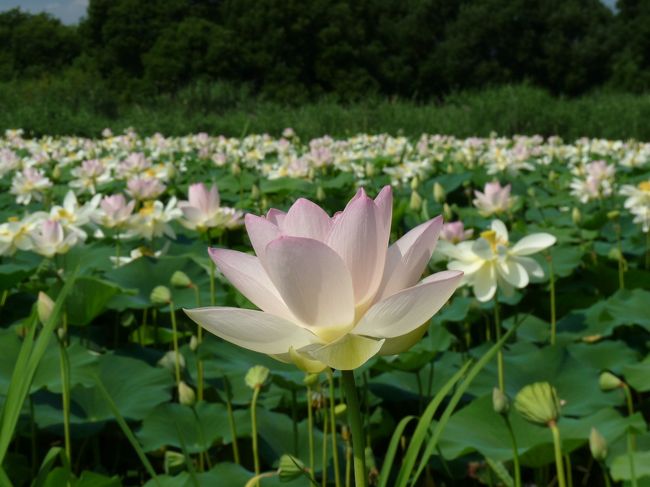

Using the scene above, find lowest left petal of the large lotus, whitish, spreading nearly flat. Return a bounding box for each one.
[184,308,316,354]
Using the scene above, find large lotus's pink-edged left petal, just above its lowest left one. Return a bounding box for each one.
[208,249,293,320]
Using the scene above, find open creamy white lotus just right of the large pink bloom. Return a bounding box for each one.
[445,220,556,302]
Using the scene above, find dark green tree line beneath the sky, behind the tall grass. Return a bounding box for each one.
[0,0,650,102]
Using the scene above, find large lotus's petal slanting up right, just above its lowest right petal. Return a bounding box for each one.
[375,216,442,301]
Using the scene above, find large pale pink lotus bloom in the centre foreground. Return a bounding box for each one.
[186,186,462,370]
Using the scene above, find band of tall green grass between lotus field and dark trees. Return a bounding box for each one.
[0,77,650,140]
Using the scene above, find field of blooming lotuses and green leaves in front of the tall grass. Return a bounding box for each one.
[0,129,650,487]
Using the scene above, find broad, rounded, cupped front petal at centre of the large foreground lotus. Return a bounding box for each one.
[266,237,354,328]
